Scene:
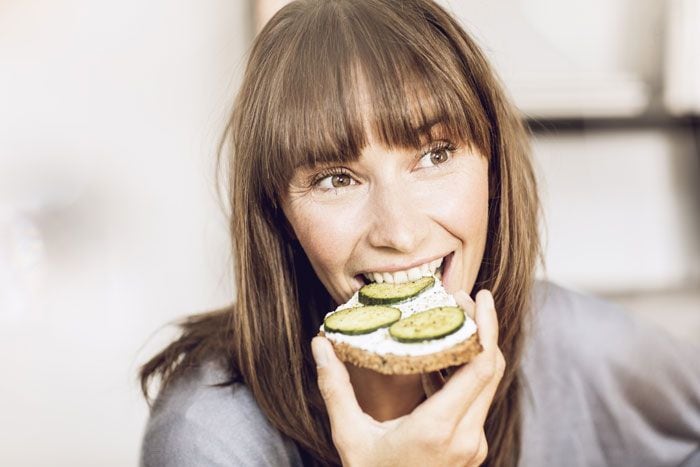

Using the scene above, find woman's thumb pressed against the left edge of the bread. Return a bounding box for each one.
[311,336,362,432]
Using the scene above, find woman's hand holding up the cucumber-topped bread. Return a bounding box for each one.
[311,290,505,466]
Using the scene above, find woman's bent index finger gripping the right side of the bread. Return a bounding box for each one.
[417,290,502,427]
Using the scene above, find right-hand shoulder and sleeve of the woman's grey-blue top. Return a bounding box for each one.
[522,285,700,466]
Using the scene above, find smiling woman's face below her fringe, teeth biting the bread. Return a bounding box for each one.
[284,125,488,303]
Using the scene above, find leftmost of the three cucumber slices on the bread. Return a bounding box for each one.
[323,306,401,336]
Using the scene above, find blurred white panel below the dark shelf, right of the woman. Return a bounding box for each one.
[534,129,700,294]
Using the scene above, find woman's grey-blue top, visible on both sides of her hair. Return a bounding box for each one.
[141,283,700,467]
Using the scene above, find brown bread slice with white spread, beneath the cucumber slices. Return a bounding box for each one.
[319,277,482,375]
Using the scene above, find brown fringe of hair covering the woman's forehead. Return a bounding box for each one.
[253,2,490,200]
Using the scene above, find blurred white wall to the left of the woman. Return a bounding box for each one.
[0,0,251,466]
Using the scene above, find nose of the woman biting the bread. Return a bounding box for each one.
[368,183,430,253]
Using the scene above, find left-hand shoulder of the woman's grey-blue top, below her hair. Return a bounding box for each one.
[141,363,300,467]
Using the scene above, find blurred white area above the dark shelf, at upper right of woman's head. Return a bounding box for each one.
[439,0,666,117]
